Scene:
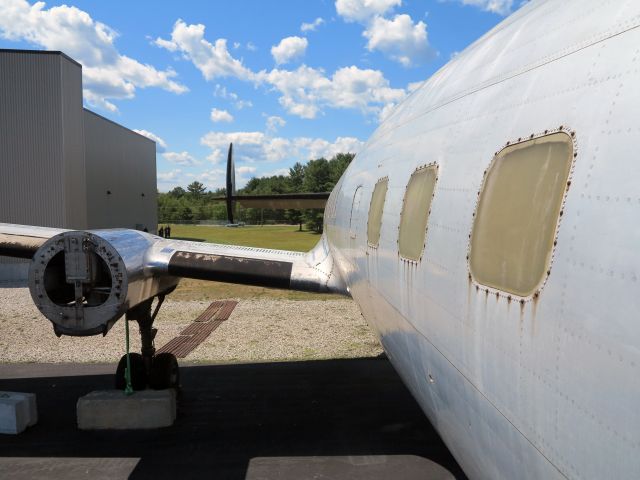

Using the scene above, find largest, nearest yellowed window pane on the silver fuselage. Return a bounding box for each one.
[469,133,573,297]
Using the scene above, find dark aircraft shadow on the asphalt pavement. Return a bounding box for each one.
[0,358,466,479]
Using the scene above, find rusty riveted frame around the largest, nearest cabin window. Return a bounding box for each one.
[467,126,578,303]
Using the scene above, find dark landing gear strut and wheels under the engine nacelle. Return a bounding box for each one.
[115,294,180,390]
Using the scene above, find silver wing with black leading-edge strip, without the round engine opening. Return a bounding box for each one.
[0,223,346,293]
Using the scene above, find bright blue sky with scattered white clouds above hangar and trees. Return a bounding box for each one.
[0,0,519,191]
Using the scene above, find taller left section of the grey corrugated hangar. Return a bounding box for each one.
[0,51,87,232]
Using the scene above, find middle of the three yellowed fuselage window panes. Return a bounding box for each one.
[398,165,438,261]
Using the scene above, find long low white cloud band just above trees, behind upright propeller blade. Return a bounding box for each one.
[200,132,363,164]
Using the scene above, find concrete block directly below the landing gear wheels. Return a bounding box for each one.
[77,389,176,430]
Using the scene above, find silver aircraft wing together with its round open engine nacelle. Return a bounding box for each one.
[0,223,349,335]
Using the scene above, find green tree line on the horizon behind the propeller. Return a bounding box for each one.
[158,153,355,232]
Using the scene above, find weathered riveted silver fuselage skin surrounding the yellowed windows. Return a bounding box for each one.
[325,0,640,479]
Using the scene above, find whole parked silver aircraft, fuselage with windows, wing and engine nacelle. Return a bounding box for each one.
[0,0,640,479]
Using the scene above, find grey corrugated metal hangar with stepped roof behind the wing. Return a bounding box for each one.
[0,49,157,281]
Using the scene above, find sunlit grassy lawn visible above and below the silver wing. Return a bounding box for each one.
[164,225,339,300]
